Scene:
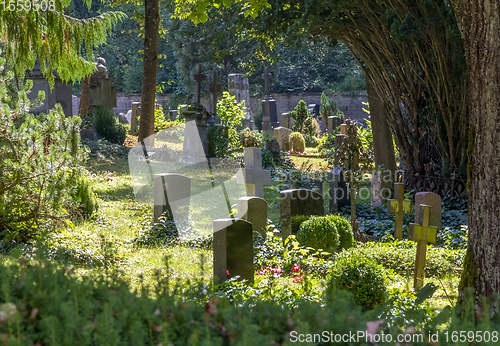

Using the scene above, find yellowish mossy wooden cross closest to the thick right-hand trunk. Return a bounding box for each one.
[410,204,437,291]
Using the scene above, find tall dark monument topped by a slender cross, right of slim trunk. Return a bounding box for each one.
[181,64,208,162]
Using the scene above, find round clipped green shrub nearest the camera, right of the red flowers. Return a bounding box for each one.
[326,255,387,309]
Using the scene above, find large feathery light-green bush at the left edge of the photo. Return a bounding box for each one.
[0,76,90,242]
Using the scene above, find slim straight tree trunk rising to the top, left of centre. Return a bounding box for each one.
[138,0,160,146]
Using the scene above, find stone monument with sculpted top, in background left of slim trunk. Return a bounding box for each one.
[89,58,116,108]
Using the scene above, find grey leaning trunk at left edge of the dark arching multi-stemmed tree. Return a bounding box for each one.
[365,74,396,203]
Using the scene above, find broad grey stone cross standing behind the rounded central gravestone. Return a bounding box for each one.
[236,148,271,198]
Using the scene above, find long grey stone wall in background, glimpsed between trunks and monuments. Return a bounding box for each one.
[73,92,368,121]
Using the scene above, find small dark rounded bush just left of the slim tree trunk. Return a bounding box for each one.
[93,106,127,145]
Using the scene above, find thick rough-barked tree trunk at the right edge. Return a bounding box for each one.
[455,0,500,302]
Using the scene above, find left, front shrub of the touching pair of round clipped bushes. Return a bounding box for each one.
[297,216,339,252]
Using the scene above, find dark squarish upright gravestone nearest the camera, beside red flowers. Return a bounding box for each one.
[213,218,254,285]
